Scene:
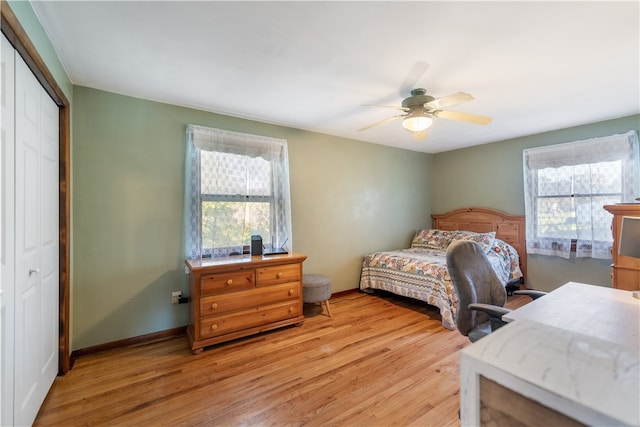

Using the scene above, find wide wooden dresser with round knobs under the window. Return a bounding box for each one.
[185,253,307,354]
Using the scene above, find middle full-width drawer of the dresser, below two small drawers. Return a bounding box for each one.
[200,282,300,317]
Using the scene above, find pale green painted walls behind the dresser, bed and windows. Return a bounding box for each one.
[9,1,640,349]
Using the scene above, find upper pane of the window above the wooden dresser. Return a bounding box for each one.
[200,151,273,196]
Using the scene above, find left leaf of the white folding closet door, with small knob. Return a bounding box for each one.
[14,52,42,425]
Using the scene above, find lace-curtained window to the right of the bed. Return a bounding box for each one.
[523,131,640,259]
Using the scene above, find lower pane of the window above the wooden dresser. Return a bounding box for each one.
[202,201,272,248]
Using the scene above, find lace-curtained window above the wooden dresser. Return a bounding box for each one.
[185,125,292,259]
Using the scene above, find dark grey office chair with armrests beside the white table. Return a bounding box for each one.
[447,240,545,342]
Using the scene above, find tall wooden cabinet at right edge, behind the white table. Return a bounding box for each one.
[604,203,640,290]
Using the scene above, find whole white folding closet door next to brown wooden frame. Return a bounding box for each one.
[14,51,59,425]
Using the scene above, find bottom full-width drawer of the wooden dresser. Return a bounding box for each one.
[200,301,302,339]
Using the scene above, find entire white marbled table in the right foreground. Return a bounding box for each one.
[460,282,640,426]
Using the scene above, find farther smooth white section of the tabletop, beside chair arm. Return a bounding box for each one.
[502,282,640,347]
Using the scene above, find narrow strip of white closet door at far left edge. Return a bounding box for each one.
[0,35,15,426]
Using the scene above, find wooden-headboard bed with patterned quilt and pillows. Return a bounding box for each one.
[360,207,527,330]
